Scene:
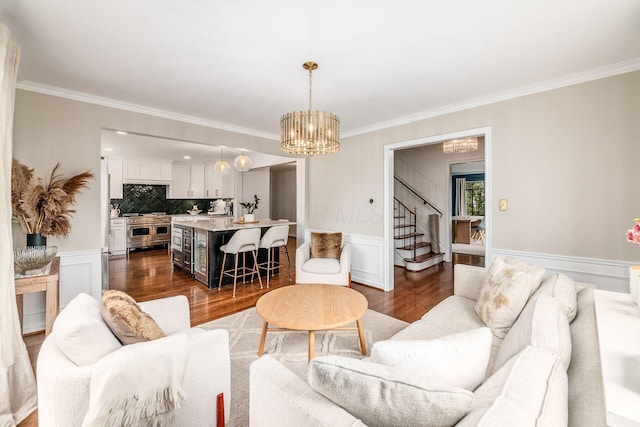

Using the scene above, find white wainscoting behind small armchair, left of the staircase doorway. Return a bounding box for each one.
[298,229,384,289]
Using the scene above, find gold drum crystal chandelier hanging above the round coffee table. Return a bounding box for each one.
[280,62,340,156]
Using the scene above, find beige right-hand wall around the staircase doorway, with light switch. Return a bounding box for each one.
[309,72,640,261]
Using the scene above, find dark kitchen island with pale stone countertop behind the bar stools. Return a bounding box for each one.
[171,219,295,289]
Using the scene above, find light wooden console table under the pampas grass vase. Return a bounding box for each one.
[15,257,60,336]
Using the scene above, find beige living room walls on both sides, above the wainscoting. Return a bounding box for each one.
[14,72,640,261]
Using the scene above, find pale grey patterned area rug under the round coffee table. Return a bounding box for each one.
[197,308,407,427]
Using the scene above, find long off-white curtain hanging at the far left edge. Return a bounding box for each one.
[0,24,37,427]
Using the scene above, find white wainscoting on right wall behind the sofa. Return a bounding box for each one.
[487,249,634,293]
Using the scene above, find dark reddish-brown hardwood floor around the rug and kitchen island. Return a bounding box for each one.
[19,239,484,427]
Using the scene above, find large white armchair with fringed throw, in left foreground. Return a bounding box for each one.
[37,294,231,427]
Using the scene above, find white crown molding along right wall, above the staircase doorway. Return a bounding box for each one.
[341,58,640,138]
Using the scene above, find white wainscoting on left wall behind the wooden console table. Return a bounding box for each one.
[23,250,102,333]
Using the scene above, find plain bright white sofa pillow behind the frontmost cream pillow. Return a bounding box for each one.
[371,327,493,391]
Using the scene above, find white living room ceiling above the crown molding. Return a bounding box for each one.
[0,0,640,139]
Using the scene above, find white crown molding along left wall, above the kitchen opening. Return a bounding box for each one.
[16,80,280,141]
